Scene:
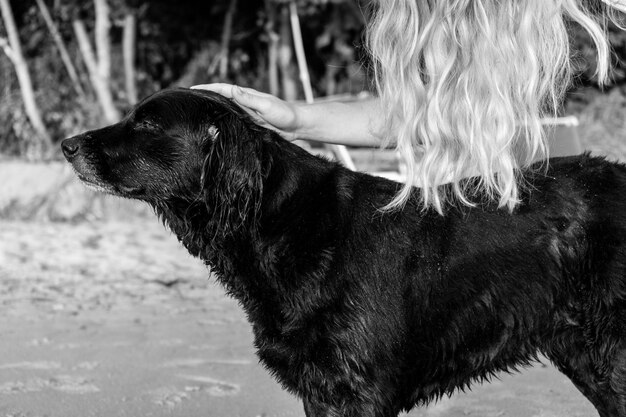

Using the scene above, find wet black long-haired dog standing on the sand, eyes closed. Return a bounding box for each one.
[62,90,626,417]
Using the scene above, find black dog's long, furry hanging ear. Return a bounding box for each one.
[201,116,263,236]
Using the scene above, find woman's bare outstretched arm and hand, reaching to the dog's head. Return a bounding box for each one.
[192,84,383,146]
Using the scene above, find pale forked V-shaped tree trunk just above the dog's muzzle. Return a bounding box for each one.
[73,0,120,123]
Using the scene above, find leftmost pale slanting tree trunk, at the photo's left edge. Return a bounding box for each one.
[0,0,52,158]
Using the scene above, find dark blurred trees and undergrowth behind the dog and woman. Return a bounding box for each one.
[0,0,626,159]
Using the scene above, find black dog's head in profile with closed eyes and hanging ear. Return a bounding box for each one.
[61,89,267,232]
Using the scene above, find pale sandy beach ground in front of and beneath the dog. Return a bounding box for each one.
[0,219,597,417]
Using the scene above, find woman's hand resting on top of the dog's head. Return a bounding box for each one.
[191,83,302,140]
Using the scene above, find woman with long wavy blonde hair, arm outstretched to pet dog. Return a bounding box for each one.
[196,0,626,214]
